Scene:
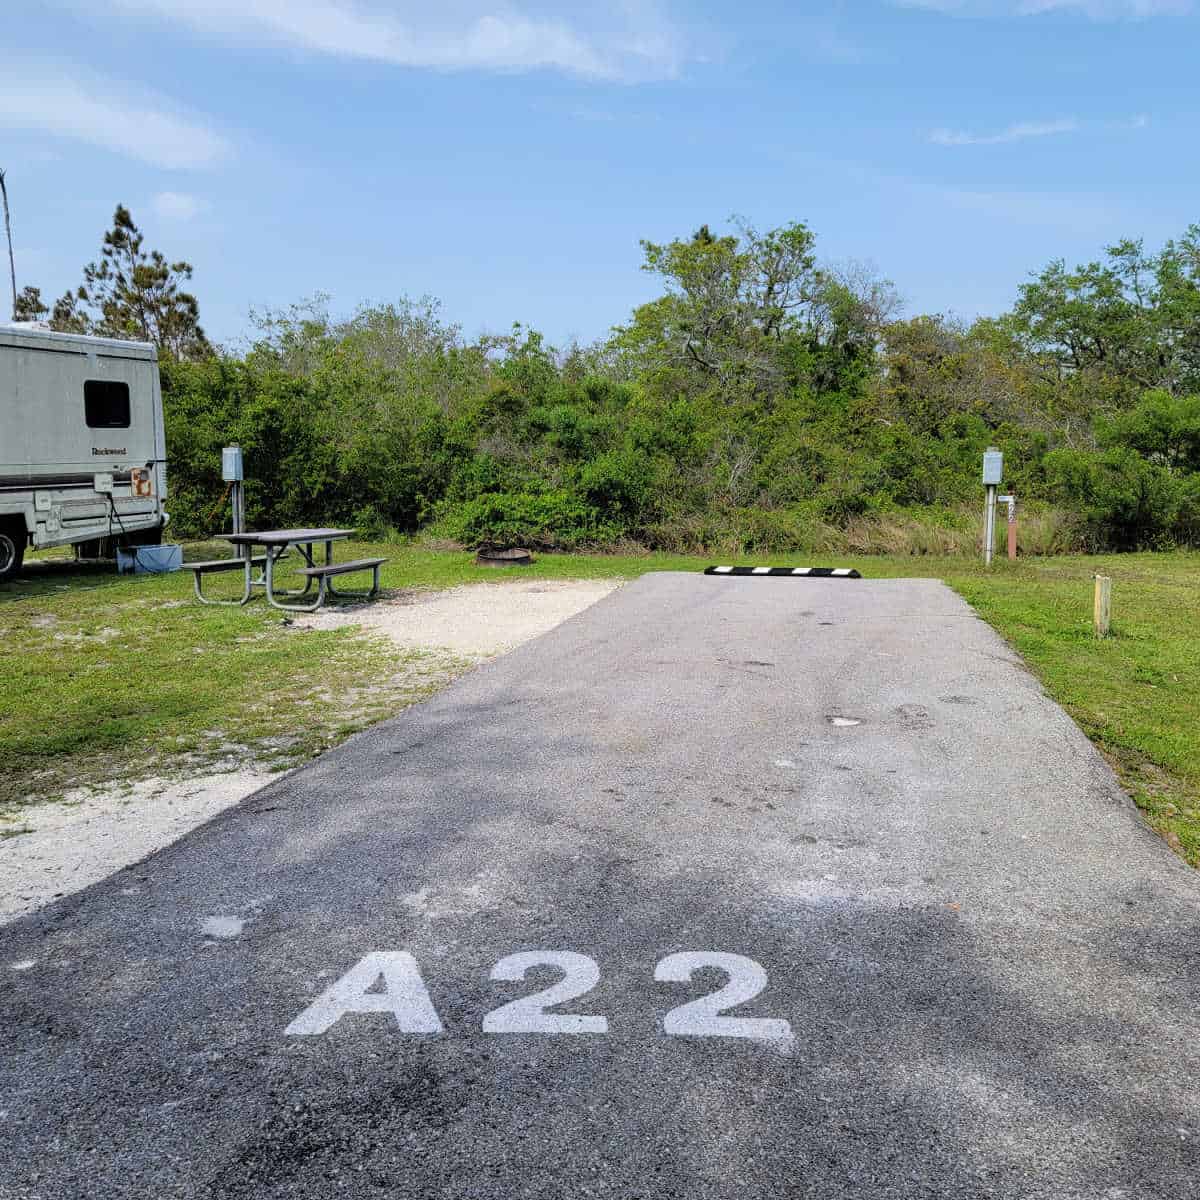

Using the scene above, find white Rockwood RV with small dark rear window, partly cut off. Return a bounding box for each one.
[0,324,169,580]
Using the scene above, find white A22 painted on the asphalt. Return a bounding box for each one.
[283,950,792,1042]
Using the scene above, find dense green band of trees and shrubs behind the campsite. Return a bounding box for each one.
[23,210,1200,551]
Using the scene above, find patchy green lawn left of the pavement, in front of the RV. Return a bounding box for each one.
[0,547,466,816]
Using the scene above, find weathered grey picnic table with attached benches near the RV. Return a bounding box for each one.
[186,529,386,612]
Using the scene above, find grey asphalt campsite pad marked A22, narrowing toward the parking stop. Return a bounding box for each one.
[0,575,1200,1200]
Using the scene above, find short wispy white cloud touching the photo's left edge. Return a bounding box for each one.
[0,56,232,169]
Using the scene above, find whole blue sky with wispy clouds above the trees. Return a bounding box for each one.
[0,0,1200,344]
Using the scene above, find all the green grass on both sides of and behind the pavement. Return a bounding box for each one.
[0,544,1200,865]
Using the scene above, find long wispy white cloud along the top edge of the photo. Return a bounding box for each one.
[84,0,683,79]
